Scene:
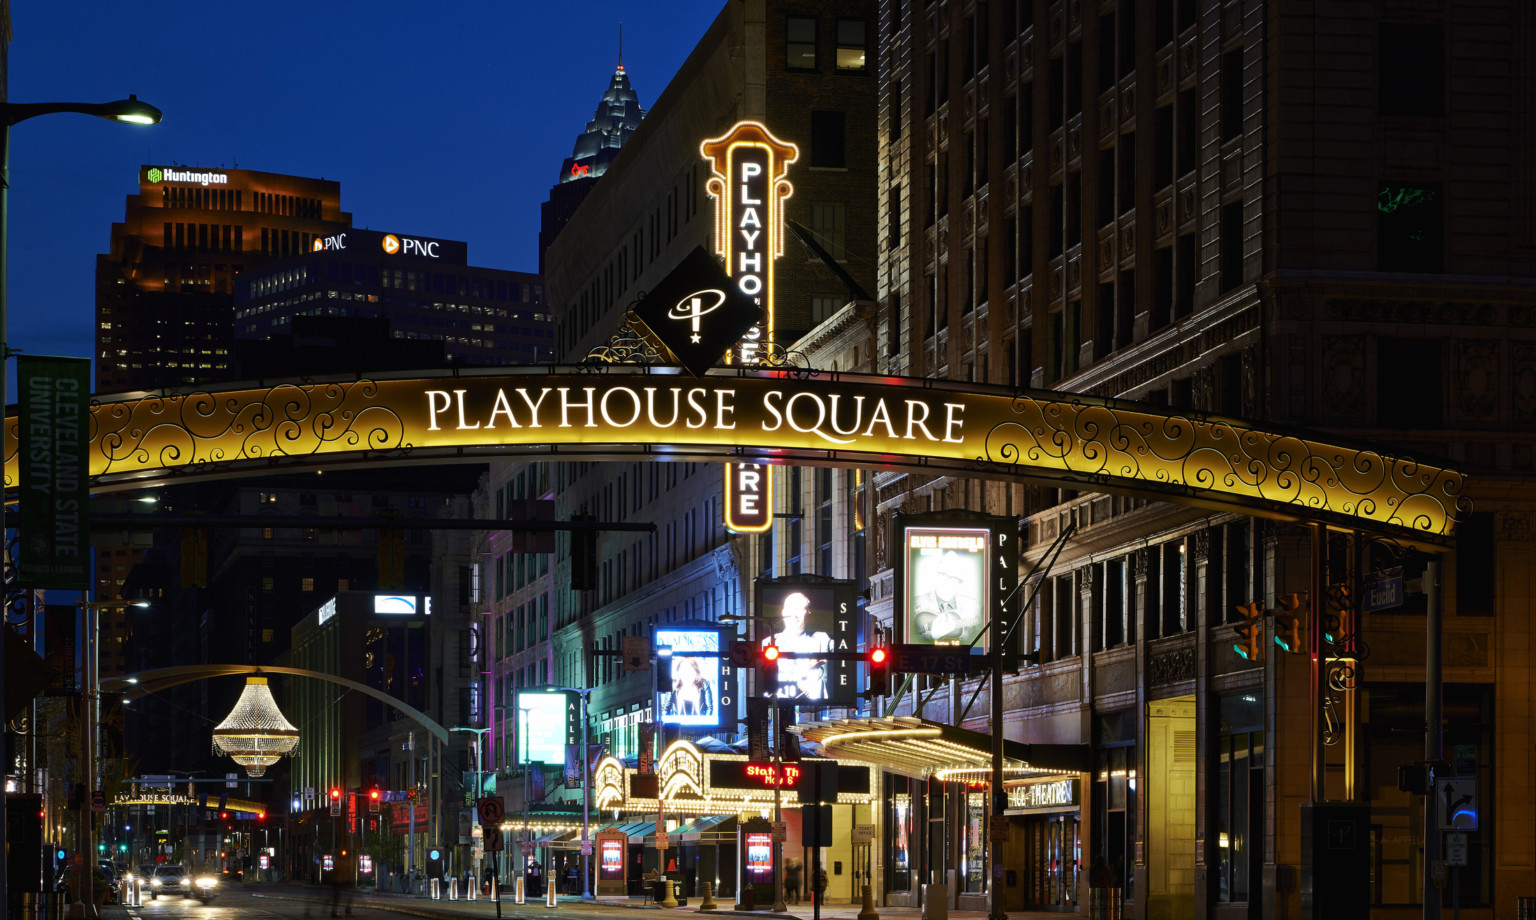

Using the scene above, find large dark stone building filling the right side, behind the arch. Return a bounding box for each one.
[871,0,1536,917]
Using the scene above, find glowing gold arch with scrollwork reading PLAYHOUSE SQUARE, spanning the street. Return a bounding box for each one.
[5,366,1465,545]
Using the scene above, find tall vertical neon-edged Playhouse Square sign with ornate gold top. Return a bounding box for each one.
[699,121,800,533]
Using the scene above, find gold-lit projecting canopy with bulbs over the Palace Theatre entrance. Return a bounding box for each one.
[790,716,1092,785]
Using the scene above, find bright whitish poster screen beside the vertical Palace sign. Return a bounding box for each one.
[902,527,991,648]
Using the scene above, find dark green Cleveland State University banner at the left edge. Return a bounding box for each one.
[17,355,91,590]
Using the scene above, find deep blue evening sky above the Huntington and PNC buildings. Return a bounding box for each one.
[8,0,723,393]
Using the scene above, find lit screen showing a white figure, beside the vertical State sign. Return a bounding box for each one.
[757,577,859,707]
